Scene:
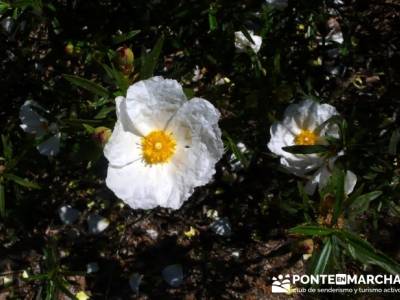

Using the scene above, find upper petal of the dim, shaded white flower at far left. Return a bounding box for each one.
[19,100,48,137]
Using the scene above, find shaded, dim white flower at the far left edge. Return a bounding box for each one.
[19,100,61,156]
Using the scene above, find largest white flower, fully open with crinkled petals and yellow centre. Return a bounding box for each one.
[104,77,224,209]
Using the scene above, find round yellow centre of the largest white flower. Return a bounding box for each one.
[142,130,176,165]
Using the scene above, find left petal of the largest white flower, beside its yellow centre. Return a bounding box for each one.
[104,120,141,167]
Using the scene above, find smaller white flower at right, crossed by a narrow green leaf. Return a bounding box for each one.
[268,100,357,194]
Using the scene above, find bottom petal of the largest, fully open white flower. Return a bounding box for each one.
[106,161,179,209]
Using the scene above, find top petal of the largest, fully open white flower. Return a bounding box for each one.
[123,76,187,136]
